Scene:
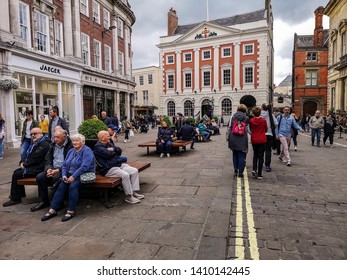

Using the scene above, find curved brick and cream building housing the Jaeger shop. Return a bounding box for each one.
[0,0,135,147]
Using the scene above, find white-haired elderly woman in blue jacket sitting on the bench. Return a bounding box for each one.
[41,134,95,222]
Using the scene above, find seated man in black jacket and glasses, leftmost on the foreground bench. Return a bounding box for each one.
[2,127,49,207]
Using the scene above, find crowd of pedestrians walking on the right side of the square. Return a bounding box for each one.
[227,104,343,180]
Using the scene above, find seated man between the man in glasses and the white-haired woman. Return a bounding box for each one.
[30,128,72,212]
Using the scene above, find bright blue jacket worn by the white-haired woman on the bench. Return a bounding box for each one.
[62,146,95,180]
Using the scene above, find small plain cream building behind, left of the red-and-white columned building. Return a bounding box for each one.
[133,66,162,115]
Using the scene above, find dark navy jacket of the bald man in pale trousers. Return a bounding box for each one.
[94,142,122,176]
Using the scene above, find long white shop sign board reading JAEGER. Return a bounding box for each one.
[12,55,80,80]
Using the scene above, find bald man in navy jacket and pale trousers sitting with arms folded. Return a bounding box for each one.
[94,131,144,204]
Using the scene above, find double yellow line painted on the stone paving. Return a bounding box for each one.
[235,166,259,260]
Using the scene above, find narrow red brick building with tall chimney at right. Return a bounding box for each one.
[292,7,329,116]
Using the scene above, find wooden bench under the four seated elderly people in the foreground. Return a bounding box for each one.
[17,162,151,208]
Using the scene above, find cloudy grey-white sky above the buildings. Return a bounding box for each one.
[129,0,329,84]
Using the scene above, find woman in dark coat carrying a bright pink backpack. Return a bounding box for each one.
[228,104,249,178]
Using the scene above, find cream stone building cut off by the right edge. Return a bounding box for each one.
[324,0,347,114]
